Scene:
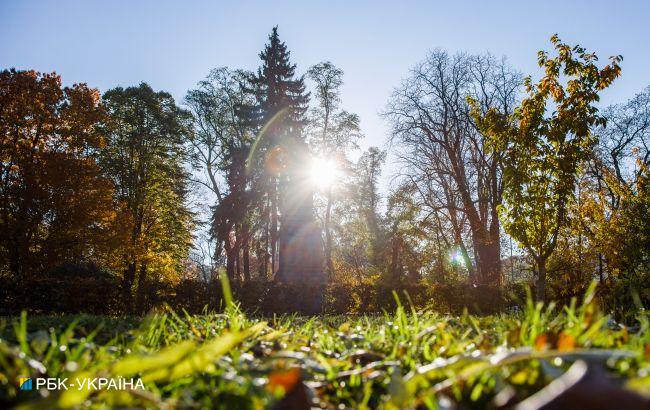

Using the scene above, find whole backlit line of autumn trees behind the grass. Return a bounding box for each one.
[0,28,650,312]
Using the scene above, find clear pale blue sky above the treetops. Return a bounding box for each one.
[0,0,650,187]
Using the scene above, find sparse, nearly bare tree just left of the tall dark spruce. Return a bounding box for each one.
[185,68,256,280]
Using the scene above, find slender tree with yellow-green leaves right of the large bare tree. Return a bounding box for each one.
[473,35,621,300]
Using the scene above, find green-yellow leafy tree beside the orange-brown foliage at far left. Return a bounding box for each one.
[101,83,193,312]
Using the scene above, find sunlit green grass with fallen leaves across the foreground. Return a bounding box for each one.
[0,286,650,409]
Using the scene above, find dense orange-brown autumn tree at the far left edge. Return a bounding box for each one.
[0,69,114,280]
